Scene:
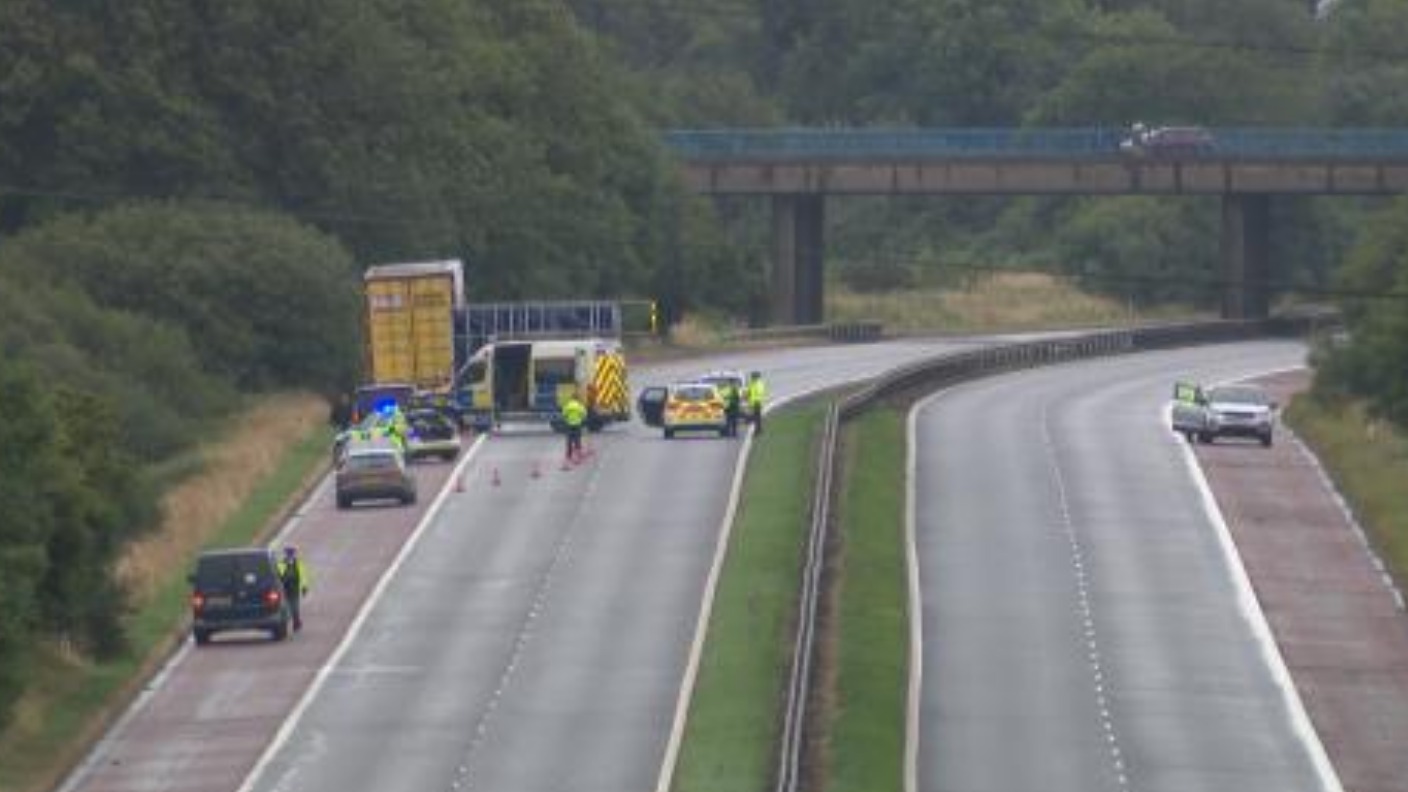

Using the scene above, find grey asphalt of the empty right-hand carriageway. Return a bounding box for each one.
[912,342,1319,792]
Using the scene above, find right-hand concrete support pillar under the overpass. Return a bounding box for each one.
[1222,194,1271,318]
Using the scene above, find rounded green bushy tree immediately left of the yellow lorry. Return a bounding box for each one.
[0,204,359,389]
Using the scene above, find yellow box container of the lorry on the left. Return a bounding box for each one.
[363,259,465,392]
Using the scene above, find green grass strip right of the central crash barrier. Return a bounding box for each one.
[814,407,910,792]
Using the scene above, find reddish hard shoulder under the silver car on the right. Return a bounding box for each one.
[1197,371,1408,792]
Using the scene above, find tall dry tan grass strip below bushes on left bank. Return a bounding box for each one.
[117,393,328,605]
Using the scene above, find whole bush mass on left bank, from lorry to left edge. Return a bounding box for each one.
[0,204,358,723]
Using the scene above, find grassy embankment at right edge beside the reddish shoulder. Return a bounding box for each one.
[1286,396,1408,586]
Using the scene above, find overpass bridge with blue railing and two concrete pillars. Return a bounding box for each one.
[665,127,1408,324]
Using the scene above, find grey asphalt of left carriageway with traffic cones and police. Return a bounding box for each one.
[239,335,991,792]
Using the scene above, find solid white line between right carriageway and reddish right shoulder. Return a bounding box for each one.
[1162,365,1345,792]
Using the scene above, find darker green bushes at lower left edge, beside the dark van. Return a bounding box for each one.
[0,355,152,724]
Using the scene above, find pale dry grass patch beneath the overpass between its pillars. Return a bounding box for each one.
[826,272,1191,333]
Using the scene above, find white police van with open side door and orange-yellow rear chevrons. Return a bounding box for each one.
[460,338,631,431]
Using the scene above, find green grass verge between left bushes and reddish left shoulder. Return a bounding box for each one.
[0,397,328,792]
